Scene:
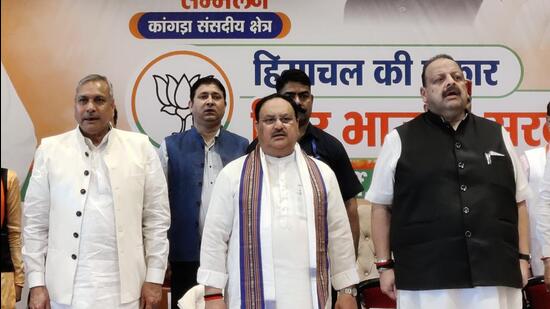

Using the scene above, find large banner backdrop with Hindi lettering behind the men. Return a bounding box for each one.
[1,0,550,199]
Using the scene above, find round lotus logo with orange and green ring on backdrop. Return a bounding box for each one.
[131,50,233,147]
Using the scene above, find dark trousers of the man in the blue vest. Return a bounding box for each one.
[170,262,199,309]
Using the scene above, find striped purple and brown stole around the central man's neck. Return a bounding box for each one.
[239,146,330,309]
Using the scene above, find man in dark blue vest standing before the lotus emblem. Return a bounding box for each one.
[160,76,248,308]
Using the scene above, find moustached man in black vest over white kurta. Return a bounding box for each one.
[366,55,529,309]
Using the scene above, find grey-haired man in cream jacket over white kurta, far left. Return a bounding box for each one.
[23,74,170,309]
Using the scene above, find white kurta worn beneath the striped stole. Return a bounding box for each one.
[197,145,359,309]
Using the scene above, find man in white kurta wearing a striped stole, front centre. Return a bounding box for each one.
[201,94,359,309]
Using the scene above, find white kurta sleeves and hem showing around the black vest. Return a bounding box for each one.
[365,128,529,309]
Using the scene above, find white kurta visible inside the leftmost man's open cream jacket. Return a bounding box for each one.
[52,132,139,309]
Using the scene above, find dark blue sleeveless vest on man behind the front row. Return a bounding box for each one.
[165,127,248,262]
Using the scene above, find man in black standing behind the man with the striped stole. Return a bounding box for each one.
[247,69,363,252]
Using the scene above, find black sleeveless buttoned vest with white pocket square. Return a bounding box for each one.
[390,112,521,290]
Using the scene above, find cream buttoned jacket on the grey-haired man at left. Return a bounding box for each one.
[23,128,170,305]
